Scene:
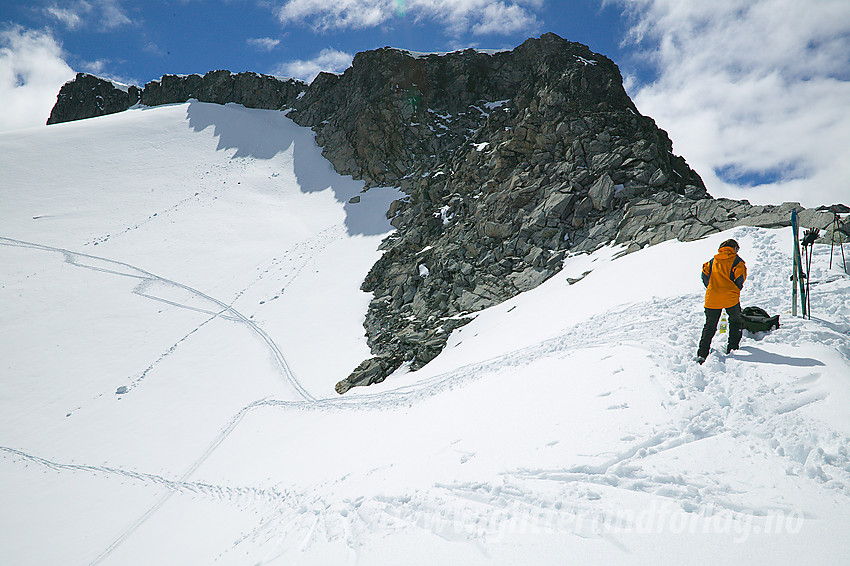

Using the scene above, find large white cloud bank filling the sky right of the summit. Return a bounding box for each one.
[618,0,850,206]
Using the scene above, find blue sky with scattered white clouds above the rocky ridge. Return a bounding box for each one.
[0,0,850,209]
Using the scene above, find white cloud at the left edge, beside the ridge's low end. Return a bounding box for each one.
[0,27,74,131]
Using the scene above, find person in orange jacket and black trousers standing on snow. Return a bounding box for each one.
[697,240,747,363]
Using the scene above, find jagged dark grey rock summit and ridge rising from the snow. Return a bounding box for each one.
[48,33,846,393]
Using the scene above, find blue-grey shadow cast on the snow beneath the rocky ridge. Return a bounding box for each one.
[186,100,404,236]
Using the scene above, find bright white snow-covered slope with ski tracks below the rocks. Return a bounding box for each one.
[0,102,850,565]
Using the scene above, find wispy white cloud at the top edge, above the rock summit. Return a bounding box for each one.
[277,0,543,35]
